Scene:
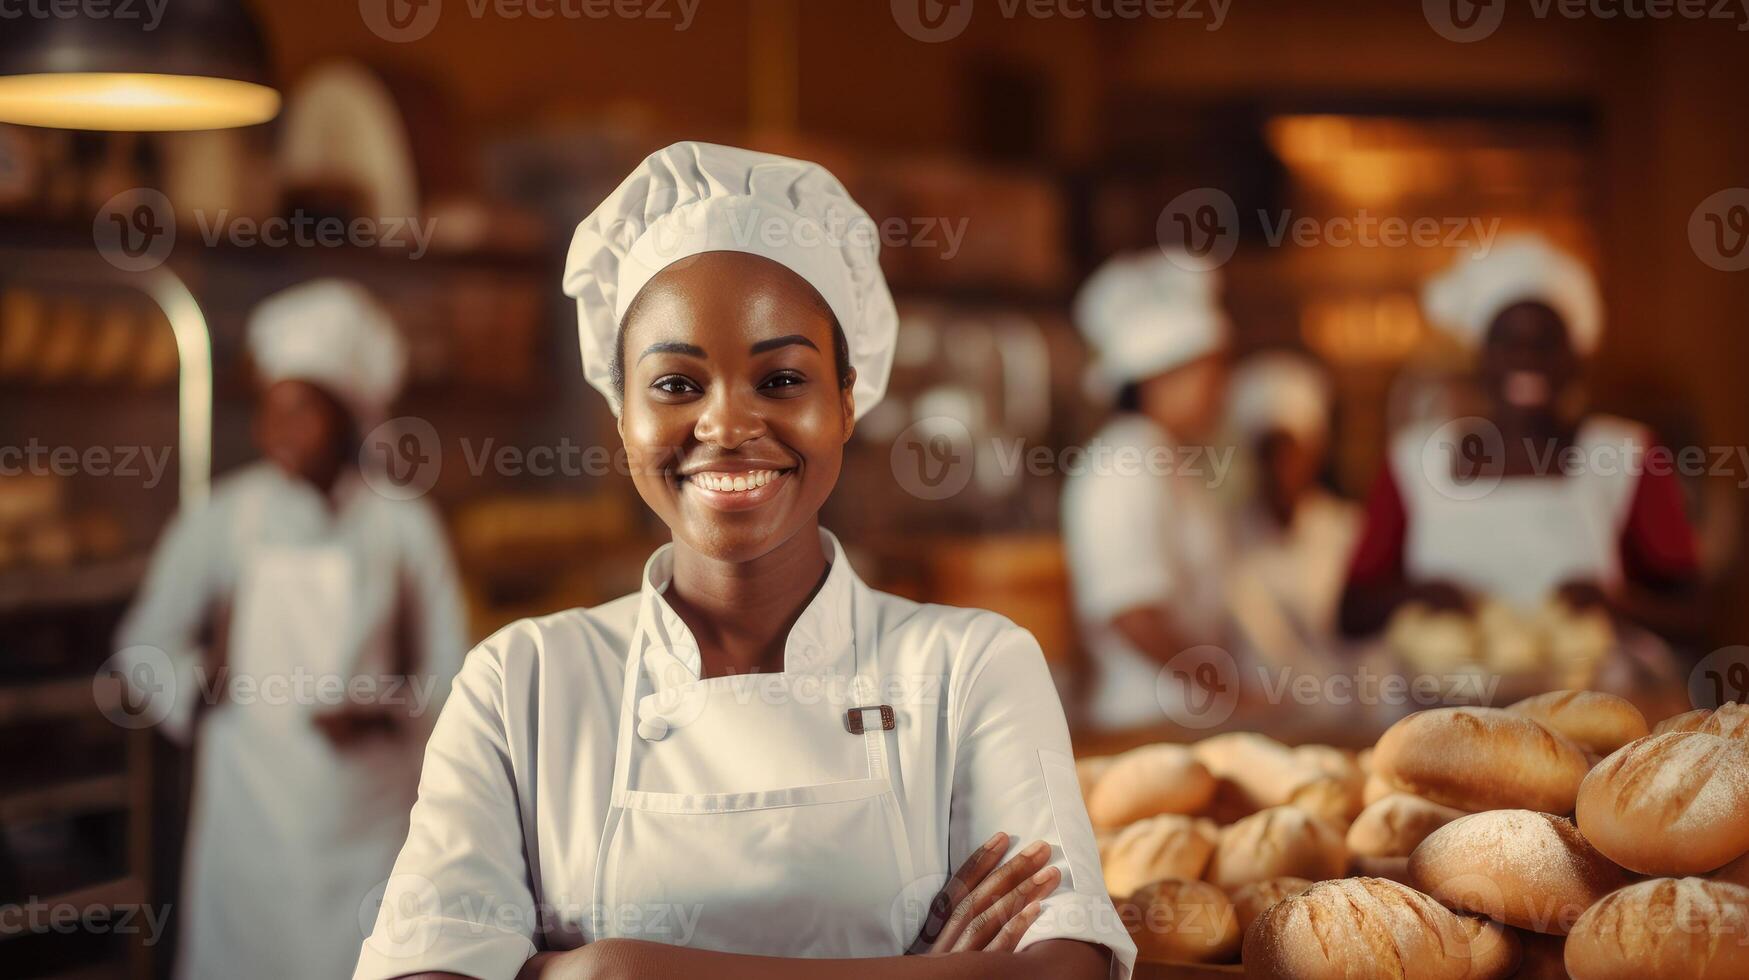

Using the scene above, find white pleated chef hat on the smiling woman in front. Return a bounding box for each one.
[565,142,899,418]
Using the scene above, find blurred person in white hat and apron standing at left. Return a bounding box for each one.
[117,280,467,980]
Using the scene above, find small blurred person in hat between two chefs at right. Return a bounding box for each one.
[1228,350,1361,663]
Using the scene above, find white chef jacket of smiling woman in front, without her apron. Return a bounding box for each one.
[355,530,1135,980]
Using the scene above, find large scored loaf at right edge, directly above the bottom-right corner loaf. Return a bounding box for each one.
[1578,732,1749,877]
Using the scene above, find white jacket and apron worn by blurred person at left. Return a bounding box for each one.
[117,464,467,980]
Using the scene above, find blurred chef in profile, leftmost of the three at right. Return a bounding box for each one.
[1063,250,1230,728]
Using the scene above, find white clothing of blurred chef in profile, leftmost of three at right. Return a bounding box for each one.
[1062,411,1228,728]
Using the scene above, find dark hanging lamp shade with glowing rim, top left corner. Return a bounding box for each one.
[0,0,280,131]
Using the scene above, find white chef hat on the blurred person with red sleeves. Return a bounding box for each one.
[1422,235,1604,354]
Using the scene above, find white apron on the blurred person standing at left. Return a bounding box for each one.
[177,546,418,980]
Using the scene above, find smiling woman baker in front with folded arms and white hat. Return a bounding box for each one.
[357,144,1135,980]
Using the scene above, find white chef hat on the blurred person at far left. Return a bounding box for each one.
[248,278,408,427]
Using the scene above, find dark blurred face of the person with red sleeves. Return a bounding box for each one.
[1481,303,1579,415]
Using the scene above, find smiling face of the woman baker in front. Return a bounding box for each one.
[619,252,855,562]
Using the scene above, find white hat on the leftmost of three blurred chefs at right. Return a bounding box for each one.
[1074,250,1228,387]
